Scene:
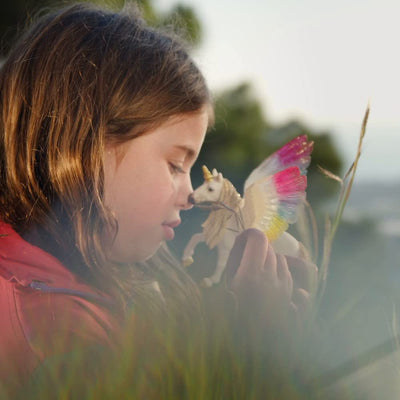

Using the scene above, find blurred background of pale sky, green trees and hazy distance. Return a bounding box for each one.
[0,0,400,399]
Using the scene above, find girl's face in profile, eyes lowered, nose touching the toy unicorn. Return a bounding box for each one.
[104,109,208,262]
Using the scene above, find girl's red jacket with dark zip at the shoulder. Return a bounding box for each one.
[0,222,119,385]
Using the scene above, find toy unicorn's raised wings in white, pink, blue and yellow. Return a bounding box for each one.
[242,135,313,240]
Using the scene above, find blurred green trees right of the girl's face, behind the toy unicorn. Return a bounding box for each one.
[193,83,342,205]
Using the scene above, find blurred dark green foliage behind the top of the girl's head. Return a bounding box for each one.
[0,0,202,57]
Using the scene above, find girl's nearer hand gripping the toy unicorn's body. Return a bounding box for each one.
[227,229,293,333]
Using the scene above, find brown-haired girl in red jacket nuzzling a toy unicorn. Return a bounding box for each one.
[0,5,312,398]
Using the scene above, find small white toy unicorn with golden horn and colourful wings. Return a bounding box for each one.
[182,135,313,287]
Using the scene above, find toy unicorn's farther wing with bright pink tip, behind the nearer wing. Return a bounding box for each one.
[244,135,314,192]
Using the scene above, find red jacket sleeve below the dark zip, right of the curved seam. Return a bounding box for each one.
[15,287,117,360]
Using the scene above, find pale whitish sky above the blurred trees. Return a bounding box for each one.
[158,0,400,185]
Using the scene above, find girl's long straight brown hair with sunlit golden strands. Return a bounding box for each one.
[0,4,210,296]
